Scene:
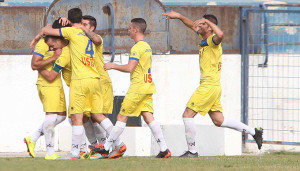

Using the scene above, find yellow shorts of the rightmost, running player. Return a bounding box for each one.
[186,85,223,116]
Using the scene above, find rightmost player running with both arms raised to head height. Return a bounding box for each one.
[163,11,263,157]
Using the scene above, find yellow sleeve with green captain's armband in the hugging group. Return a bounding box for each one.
[53,48,71,73]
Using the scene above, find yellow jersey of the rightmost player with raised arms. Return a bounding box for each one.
[199,34,223,85]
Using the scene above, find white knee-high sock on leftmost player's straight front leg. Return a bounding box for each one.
[43,114,57,156]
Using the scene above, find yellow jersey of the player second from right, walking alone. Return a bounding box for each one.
[128,41,155,94]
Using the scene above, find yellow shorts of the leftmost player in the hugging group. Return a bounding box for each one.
[37,85,66,112]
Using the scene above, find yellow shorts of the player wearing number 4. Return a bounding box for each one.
[69,78,103,115]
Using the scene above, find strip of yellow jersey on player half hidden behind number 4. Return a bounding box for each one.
[95,35,111,83]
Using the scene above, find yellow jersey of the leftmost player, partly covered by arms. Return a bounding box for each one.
[32,39,62,86]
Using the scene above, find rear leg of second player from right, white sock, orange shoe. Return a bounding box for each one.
[141,111,171,158]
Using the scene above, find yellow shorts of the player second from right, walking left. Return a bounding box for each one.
[120,93,153,117]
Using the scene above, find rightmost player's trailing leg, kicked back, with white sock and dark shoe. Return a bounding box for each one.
[209,111,263,149]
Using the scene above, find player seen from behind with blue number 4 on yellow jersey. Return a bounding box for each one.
[31,8,113,159]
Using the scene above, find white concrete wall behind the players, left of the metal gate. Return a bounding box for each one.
[0,54,241,156]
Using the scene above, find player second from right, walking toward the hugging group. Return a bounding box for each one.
[92,18,171,158]
